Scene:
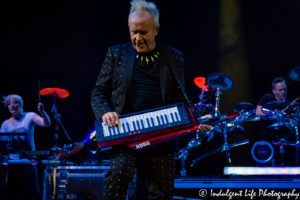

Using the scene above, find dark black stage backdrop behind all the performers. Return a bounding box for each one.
[0,0,300,175]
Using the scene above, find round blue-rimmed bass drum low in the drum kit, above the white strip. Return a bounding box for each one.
[251,141,274,165]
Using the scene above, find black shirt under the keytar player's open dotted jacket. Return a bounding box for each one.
[122,43,163,114]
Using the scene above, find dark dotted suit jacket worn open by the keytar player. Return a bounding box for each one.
[91,42,199,119]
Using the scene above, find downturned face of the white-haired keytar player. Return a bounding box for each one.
[128,11,159,53]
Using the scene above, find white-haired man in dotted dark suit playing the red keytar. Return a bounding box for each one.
[91,0,210,200]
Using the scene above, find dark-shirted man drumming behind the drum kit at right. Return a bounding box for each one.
[256,78,291,141]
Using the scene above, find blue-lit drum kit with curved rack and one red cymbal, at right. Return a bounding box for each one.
[176,66,300,176]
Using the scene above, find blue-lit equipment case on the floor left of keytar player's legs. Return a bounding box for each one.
[43,166,110,200]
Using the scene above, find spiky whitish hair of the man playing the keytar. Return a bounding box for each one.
[128,0,159,28]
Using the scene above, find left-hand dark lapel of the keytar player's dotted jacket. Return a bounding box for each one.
[124,45,135,95]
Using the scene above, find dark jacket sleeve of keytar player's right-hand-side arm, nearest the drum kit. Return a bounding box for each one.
[171,52,202,118]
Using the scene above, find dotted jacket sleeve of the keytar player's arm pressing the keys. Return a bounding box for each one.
[91,47,114,119]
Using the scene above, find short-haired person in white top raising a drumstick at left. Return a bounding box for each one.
[0,94,51,200]
